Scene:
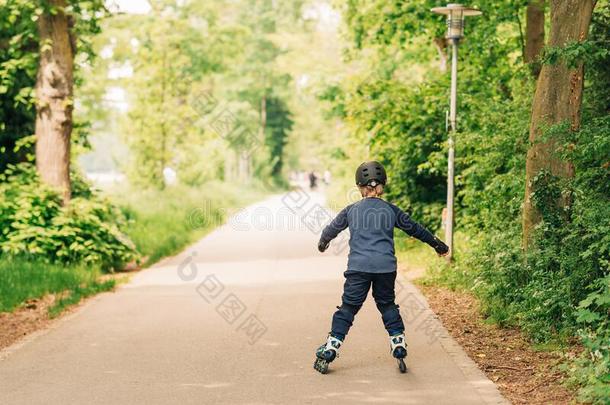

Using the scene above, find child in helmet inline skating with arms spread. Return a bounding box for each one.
[314,162,449,374]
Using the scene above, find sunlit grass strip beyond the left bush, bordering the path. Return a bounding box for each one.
[109,182,269,266]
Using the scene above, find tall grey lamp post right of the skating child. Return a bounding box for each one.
[431,3,482,261]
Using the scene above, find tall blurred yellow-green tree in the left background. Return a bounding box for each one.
[115,0,235,189]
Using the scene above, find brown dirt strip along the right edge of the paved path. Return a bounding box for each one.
[418,285,575,404]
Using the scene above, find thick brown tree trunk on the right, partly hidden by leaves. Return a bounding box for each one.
[523,0,595,249]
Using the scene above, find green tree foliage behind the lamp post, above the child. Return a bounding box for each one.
[323,0,525,229]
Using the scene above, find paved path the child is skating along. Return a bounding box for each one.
[0,194,505,405]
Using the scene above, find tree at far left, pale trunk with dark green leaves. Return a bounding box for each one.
[0,0,106,202]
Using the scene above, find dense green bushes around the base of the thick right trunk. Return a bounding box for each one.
[430,64,610,403]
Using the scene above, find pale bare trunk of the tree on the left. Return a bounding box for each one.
[36,0,74,204]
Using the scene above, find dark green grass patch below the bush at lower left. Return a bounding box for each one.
[0,258,114,313]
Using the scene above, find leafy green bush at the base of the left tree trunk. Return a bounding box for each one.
[0,164,136,269]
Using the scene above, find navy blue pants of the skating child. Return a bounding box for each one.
[331,270,405,340]
